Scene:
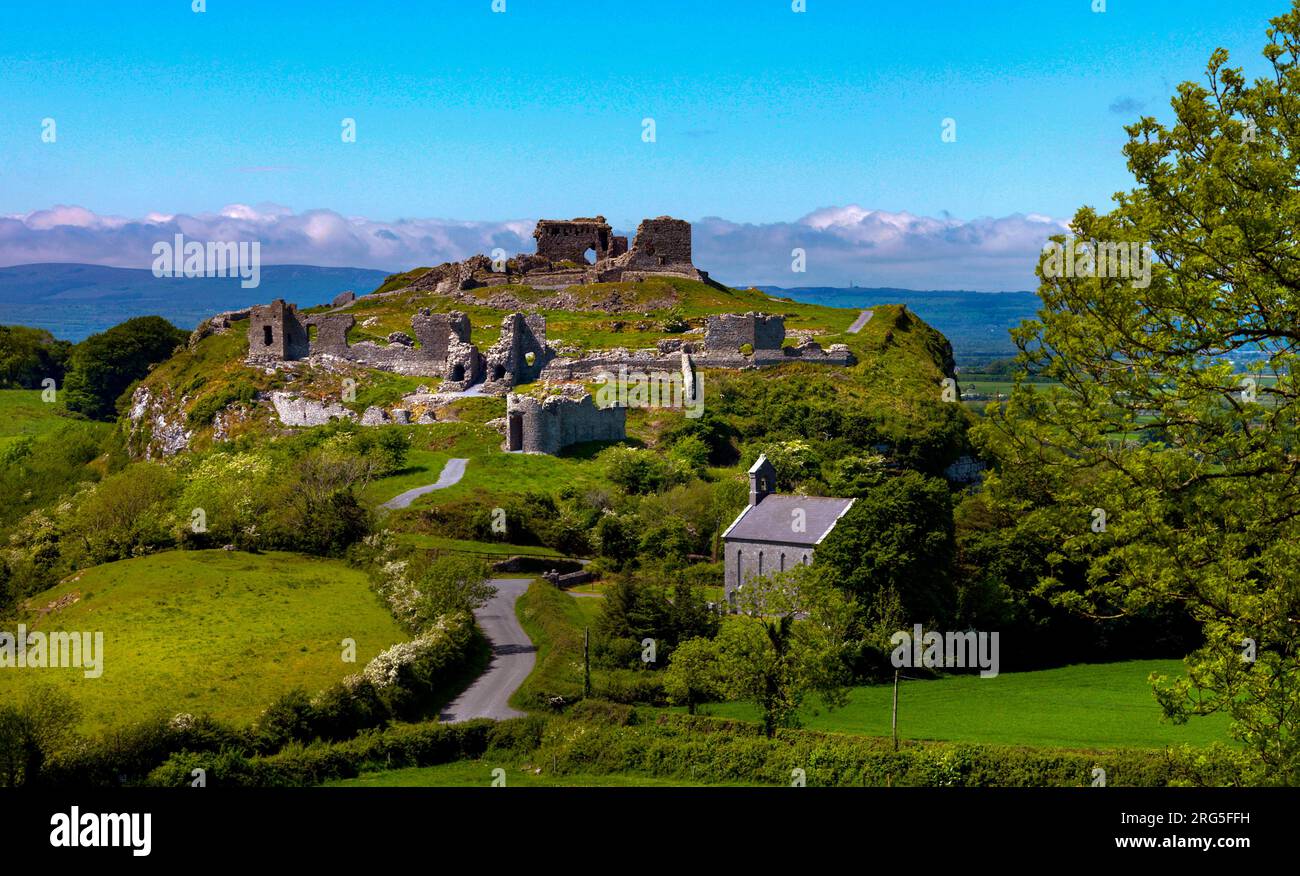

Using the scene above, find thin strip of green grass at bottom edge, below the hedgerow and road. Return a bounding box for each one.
[324,760,754,788]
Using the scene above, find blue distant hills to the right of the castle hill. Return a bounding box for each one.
[757,286,1043,368]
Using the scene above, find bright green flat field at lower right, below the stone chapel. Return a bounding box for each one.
[701,660,1230,749]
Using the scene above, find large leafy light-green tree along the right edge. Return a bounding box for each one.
[978,3,1300,784]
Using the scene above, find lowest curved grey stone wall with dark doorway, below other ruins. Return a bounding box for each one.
[506,390,628,454]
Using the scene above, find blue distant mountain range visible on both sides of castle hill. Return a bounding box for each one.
[0,264,1040,367]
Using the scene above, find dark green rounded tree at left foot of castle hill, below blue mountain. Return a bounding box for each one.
[64,316,189,420]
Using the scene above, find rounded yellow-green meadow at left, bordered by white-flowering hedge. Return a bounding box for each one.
[0,551,410,732]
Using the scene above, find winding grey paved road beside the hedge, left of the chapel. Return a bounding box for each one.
[439,578,537,724]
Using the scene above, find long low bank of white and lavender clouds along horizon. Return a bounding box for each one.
[0,204,1067,291]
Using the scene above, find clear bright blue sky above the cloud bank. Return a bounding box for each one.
[0,0,1286,285]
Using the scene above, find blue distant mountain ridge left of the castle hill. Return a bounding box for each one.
[0,264,387,341]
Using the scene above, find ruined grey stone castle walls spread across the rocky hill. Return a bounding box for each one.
[227,210,855,454]
